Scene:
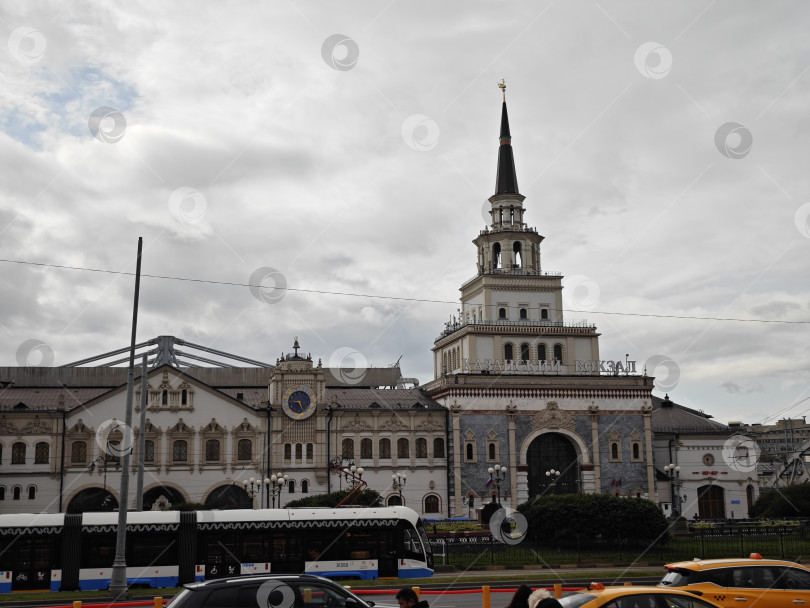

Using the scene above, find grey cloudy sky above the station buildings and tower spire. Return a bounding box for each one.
[0,0,810,422]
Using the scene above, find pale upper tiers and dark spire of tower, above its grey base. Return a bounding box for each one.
[433,84,599,378]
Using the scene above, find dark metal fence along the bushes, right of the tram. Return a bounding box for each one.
[431,526,810,568]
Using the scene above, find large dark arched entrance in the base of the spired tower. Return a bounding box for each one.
[526,433,580,498]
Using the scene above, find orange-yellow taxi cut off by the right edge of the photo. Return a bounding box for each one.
[658,553,810,608]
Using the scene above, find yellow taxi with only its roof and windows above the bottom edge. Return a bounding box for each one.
[558,583,720,608]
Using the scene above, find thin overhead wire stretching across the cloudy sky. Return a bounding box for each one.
[0,258,810,325]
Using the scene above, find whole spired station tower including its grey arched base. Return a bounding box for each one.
[423,83,655,515]
